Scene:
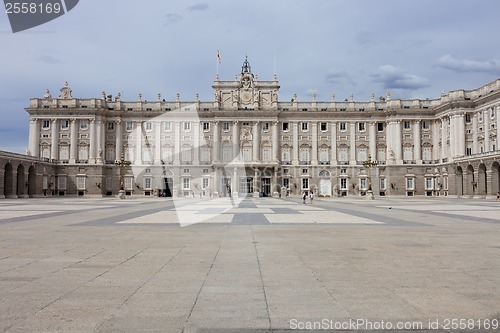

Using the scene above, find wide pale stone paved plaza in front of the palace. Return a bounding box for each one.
[0,197,500,333]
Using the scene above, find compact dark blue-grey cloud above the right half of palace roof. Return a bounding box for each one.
[371,65,429,90]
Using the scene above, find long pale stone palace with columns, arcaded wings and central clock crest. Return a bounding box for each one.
[0,60,500,197]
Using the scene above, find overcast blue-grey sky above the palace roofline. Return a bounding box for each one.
[0,0,500,153]
